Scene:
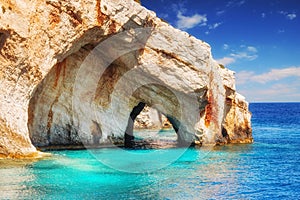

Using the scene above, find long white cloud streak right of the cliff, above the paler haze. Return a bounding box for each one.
[236,67,300,84]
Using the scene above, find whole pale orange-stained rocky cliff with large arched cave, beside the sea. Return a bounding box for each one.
[0,0,252,157]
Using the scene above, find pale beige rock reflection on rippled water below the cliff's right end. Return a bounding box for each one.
[151,150,245,199]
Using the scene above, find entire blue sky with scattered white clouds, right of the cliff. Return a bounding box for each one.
[141,0,300,102]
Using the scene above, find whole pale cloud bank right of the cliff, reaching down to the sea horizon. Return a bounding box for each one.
[236,66,300,102]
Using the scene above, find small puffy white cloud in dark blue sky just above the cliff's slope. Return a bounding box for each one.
[176,11,207,30]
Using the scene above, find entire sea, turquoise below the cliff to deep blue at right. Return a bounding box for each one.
[0,103,300,199]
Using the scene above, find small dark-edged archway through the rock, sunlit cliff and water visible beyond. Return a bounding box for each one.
[124,102,185,149]
